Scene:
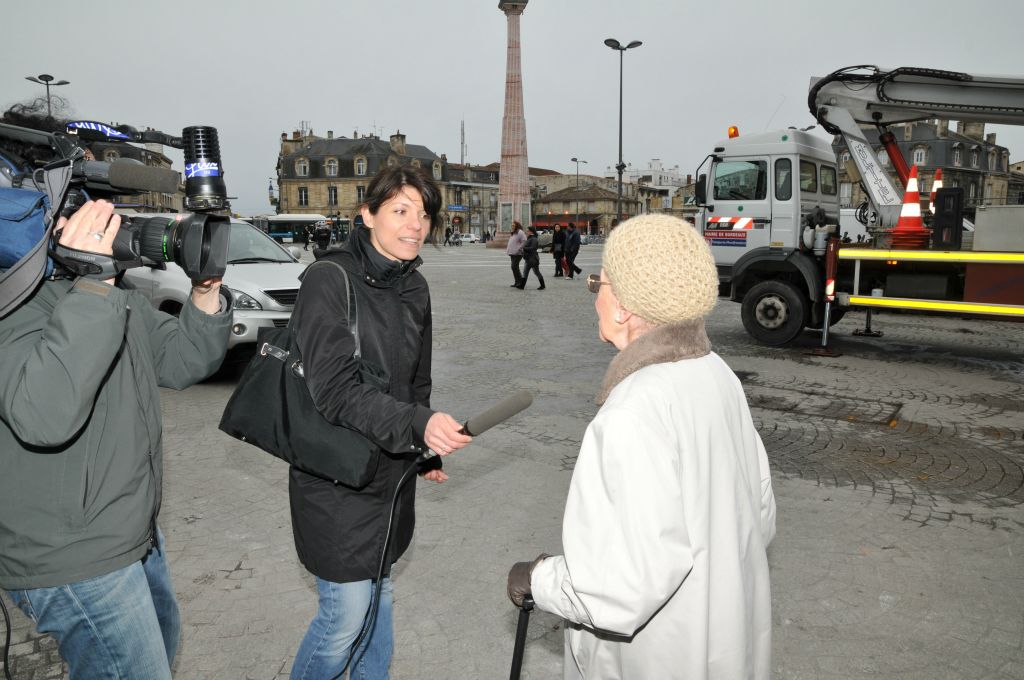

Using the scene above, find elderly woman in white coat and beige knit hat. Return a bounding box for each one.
[508,215,775,680]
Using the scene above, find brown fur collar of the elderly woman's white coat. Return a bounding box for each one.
[597,318,711,406]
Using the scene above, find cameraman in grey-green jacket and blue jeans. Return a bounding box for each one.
[0,201,231,680]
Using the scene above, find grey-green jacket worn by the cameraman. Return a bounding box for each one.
[0,279,231,590]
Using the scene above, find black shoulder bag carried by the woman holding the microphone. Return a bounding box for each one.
[220,262,389,490]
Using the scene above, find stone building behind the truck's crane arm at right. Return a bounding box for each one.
[833,120,1014,211]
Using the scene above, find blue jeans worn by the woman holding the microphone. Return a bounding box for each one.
[291,577,394,680]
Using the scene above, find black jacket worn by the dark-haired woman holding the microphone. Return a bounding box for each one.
[289,227,433,583]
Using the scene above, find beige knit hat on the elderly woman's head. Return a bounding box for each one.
[602,214,718,326]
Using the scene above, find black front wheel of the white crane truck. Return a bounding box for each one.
[741,281,809,347]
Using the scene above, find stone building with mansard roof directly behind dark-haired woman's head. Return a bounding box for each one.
[276,130,447,222]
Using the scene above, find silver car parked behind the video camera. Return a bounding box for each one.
[125,215,306,349]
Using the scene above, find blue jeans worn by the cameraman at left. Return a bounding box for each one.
[7,530,181,680]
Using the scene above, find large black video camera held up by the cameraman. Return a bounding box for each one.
[0,121,230,281]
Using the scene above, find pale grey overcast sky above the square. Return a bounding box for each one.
[8,0,1024,215]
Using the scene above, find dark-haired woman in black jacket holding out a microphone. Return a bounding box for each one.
[289,166,470,680]
